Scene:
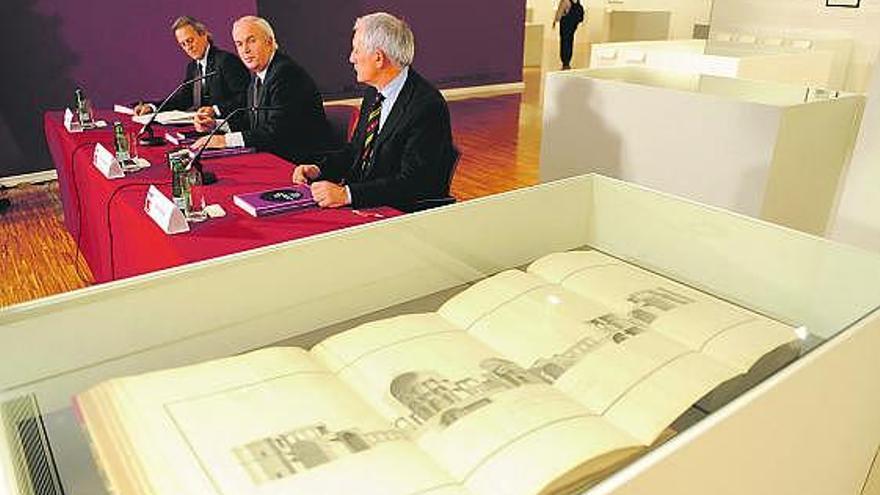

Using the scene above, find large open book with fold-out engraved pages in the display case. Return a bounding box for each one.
[75,251,799,495]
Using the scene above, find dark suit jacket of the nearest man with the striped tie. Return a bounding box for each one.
[321,68,458,210]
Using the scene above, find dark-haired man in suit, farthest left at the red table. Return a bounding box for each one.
[134,16,250,115]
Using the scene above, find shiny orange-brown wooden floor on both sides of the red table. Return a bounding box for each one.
[0,69,542,307]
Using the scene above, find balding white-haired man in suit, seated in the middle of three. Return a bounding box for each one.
[193,16,330,161]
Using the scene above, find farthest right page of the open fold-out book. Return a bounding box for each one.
[528,251,797,373]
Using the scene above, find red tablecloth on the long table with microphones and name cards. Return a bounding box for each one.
[44,112,400,282]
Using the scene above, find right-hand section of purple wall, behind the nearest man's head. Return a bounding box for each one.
[257,0,525,98]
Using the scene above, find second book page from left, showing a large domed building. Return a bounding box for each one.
[312,313,638,495]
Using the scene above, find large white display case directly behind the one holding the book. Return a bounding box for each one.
[540,67,864,234]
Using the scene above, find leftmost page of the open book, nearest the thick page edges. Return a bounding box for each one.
[79,348,468,495]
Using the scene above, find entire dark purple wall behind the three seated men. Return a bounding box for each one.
[0,0,525,176]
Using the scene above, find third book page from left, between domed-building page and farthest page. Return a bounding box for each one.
[438,271,738,445]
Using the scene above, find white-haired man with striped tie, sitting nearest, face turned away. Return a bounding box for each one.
[293,12,458,210]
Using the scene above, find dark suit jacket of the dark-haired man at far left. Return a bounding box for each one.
[163,45,250,114]
